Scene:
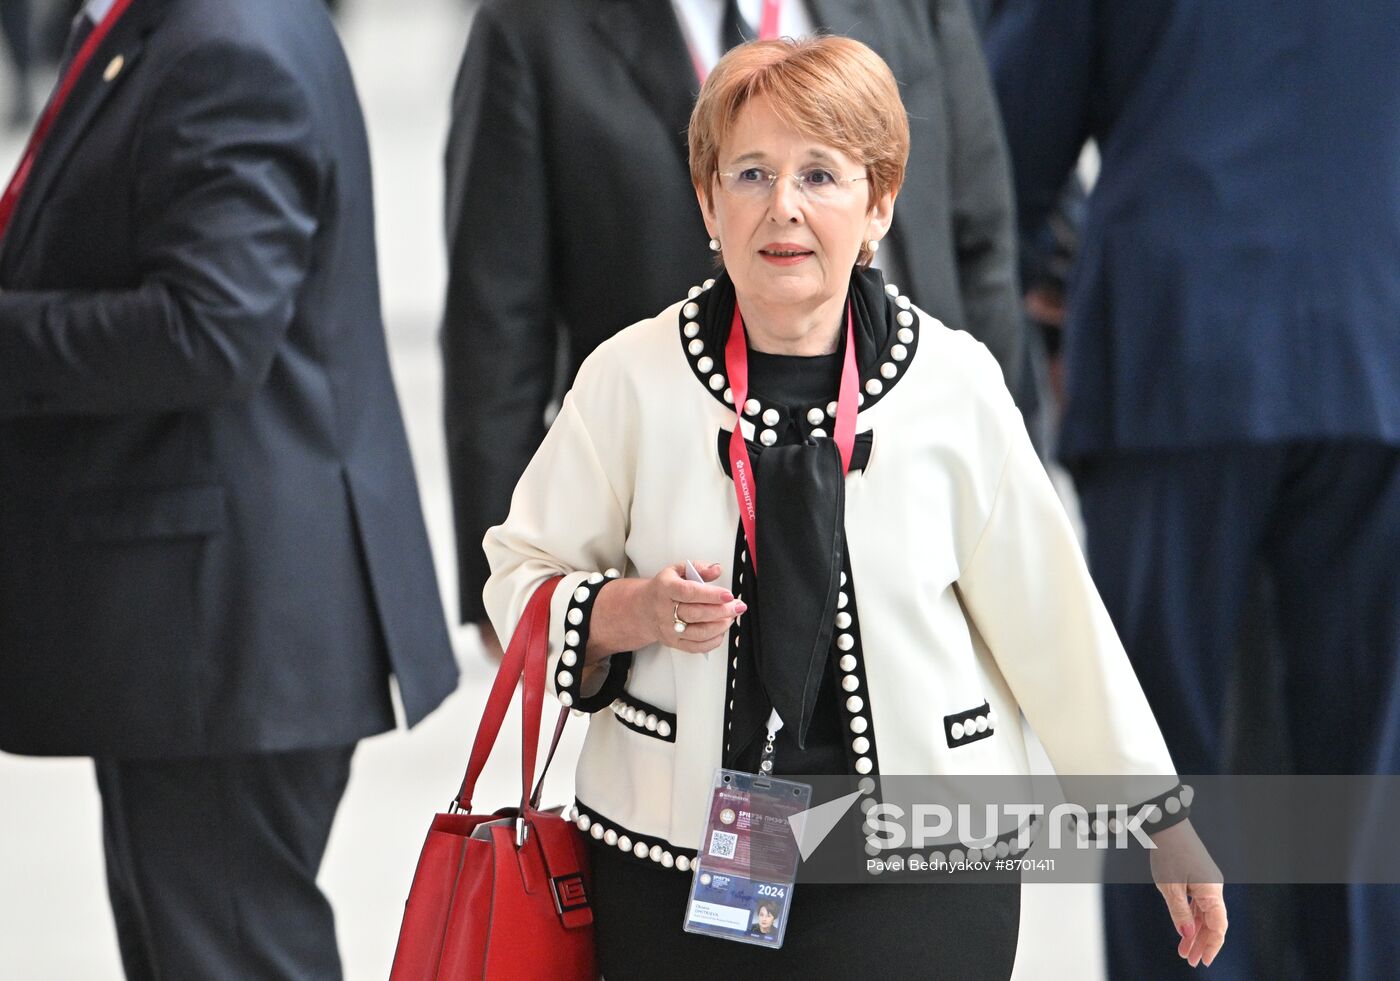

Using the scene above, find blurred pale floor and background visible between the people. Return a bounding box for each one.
[0,0,1103,981]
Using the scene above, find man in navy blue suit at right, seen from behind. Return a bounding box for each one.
[990,0,1400,981]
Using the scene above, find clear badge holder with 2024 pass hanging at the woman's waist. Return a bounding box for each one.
[685,710,812,949]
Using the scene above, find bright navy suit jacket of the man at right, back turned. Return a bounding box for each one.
[988,0,1400,458]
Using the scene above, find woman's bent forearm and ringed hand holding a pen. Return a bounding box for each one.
[584,563,749,663]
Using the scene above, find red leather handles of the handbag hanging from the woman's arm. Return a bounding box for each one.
[454,575,563,813]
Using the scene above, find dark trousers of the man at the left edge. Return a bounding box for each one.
[95,746,354,981]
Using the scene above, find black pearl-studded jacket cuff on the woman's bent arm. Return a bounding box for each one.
[546,568,631,712]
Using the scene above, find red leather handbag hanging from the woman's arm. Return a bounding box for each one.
[389,577,598,981]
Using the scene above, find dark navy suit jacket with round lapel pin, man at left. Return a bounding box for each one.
[0,0,456,757]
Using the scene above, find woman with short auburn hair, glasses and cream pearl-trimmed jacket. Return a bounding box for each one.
[484,36,1225,981]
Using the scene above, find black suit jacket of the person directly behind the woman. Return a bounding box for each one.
[442,0,1022,620]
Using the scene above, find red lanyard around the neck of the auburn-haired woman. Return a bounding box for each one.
[724,301,860,572]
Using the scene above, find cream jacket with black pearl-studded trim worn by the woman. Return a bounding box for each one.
[484,279,1175,869]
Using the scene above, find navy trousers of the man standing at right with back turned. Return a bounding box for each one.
[1075,441,1400,981]
